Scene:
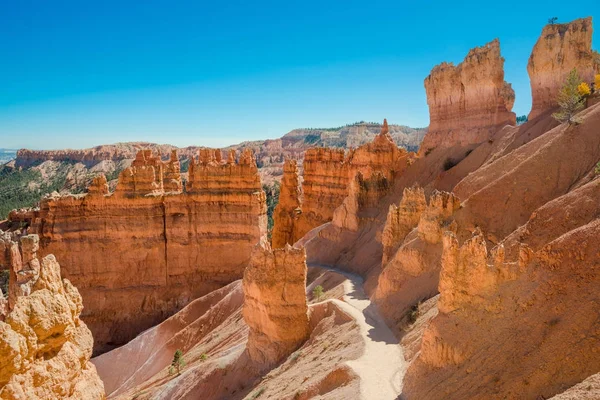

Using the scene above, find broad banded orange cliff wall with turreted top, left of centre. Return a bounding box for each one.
[12,149,266,352]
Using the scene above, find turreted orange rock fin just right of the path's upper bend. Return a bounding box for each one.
[373,187,460,334]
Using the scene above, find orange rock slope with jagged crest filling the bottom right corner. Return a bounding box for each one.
[403,217,600,399]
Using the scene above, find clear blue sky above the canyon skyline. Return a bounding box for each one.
[0,0,600,149]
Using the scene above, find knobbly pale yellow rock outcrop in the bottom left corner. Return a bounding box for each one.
[0,235,105,400]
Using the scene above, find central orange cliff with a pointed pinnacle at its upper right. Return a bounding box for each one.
[273,120,413,247]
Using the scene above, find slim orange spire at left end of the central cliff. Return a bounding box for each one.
[271,160,302,249]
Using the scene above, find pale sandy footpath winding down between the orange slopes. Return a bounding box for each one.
[311,265,408,400]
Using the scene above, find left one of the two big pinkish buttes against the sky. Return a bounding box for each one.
[419,39,516,154]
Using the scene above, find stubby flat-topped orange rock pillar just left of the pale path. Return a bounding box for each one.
[243,244,309,369]
